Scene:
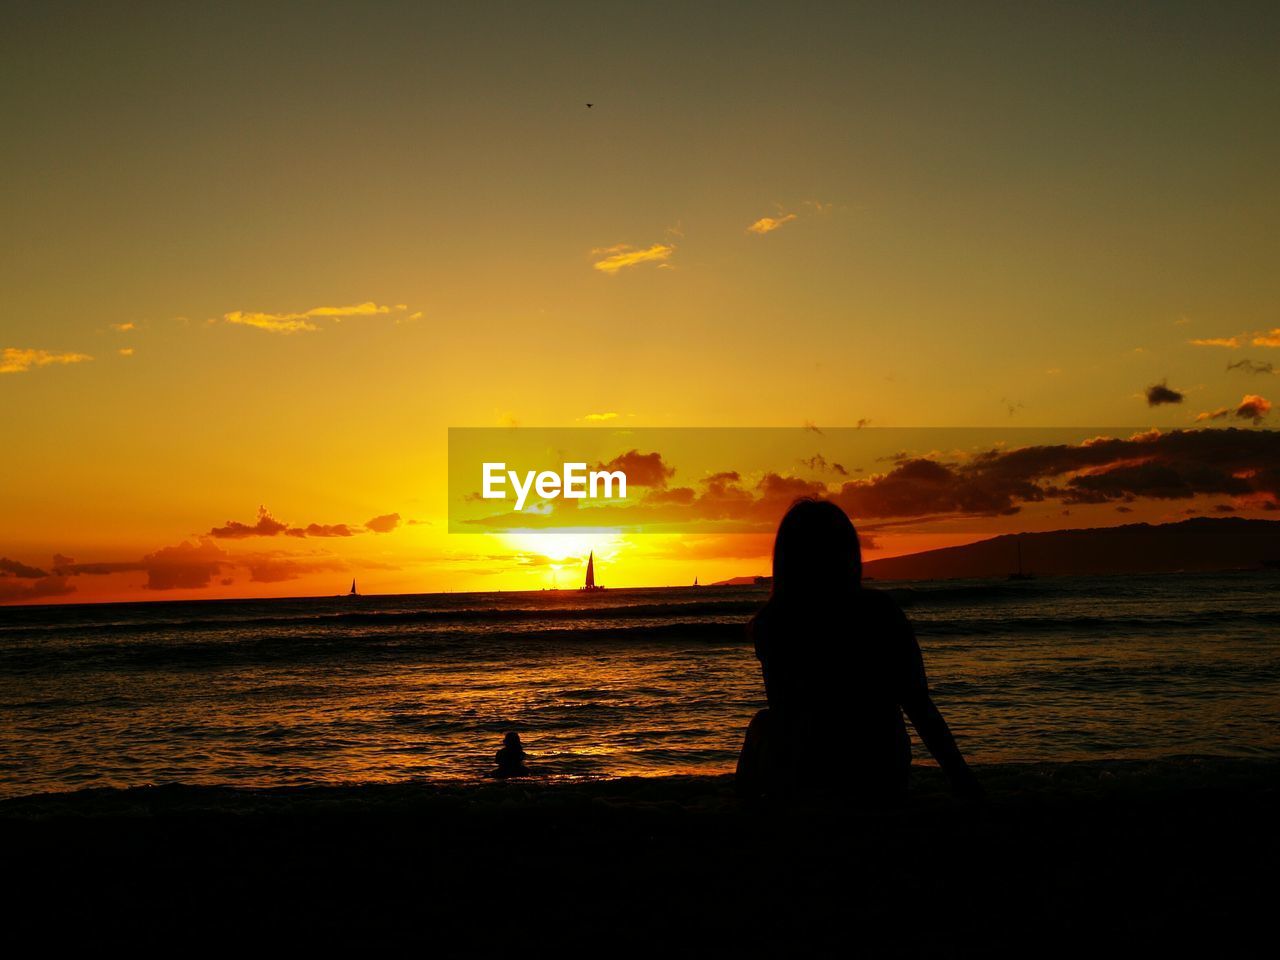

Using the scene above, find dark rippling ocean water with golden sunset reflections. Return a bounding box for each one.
[0,571,1280,796]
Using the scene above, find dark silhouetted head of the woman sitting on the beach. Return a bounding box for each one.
[773,497,863,600]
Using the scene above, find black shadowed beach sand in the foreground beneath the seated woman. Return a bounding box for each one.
[0,759,1280,956]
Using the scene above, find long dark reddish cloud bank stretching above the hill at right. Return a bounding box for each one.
[471,427,1280,532]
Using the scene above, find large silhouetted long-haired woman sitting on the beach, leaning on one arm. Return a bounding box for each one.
[737,498,980,801]
